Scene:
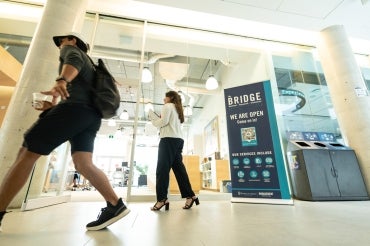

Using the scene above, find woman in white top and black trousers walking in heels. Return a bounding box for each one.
[149,91,199,211]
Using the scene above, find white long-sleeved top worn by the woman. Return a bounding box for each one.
[149,103,182,138]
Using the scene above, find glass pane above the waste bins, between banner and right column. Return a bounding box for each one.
[272,49,341,139]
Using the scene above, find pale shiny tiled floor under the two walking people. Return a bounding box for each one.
[0,192,370,246]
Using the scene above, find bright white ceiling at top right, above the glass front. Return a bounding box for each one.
[134,0,370,44]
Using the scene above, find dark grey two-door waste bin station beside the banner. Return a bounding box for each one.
[287,141,368,201]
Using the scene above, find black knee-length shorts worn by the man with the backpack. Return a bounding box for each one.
[23,103,101,155]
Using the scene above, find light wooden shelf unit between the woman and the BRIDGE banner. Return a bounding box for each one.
[200,158,230,191]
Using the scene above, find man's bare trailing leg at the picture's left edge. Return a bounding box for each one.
[0,147,40,211]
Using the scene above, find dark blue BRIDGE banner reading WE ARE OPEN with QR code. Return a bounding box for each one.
[224,81,293,204]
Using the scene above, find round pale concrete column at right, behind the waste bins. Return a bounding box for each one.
[318,26,370,193]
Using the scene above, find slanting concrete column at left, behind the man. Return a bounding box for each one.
[0,0,88,207]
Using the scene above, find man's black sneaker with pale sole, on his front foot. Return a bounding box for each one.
[86,198,130,231]
